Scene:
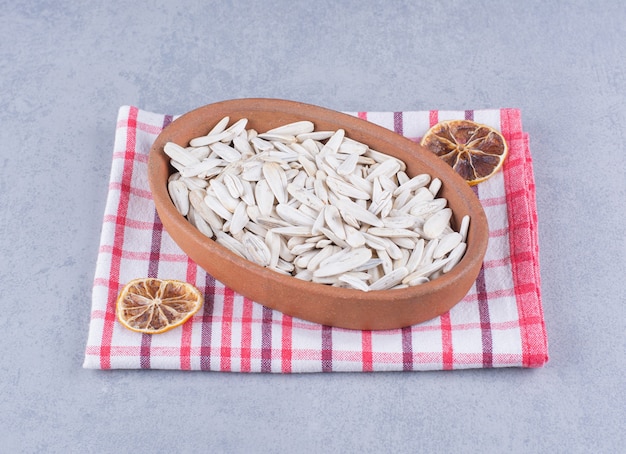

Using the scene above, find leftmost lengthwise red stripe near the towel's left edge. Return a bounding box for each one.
[100,107,139,369]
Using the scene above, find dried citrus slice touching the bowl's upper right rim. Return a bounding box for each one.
[421,120,509,186]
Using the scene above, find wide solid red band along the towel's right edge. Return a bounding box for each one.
[500,109,548,367]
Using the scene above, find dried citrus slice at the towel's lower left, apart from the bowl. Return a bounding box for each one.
[116,278,204,334]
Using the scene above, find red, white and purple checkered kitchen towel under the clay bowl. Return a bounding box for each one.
[84,106,548,373]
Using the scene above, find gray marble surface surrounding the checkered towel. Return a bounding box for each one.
[0,0,626,453]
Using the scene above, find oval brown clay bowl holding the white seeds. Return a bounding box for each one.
[148,99,488,330]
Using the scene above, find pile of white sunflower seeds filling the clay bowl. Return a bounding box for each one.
[164,117,469,291]
